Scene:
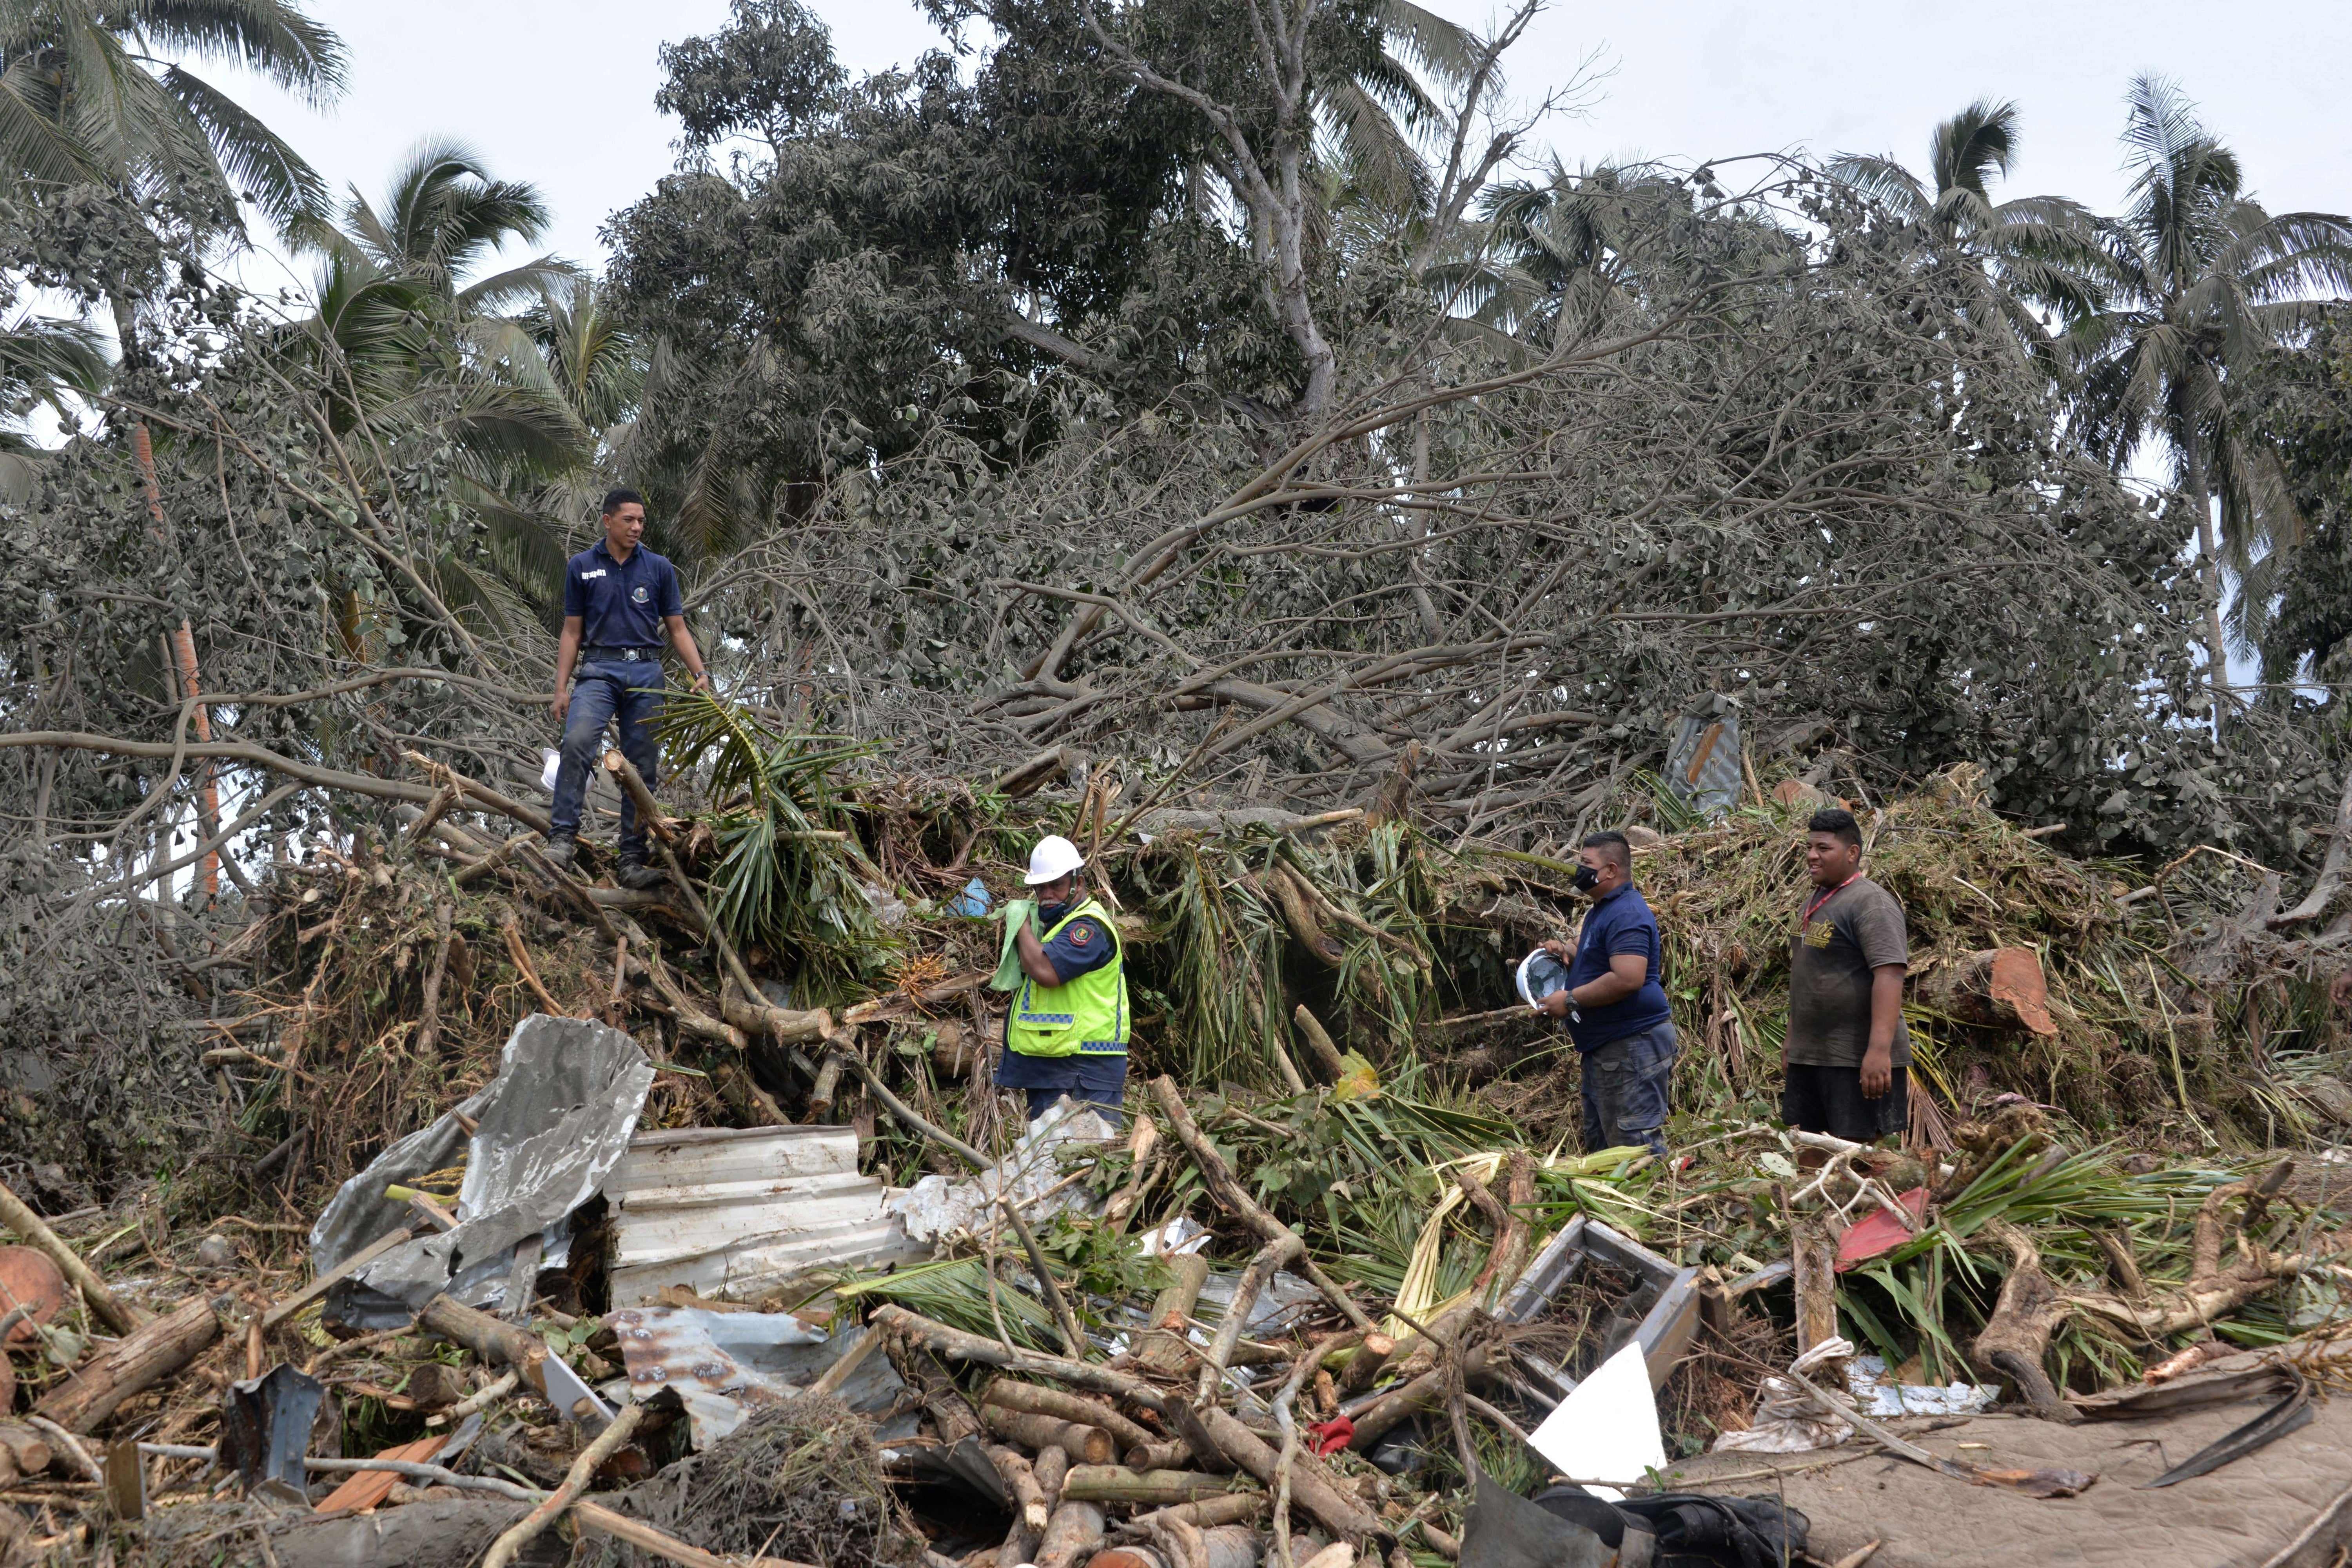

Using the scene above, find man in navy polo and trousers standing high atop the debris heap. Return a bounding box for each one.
[548,486,710,889]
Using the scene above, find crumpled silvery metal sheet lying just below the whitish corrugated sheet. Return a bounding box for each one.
[604,1307,917,1450]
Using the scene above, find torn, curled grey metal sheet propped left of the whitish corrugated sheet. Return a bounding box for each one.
[310,1013,654,1330]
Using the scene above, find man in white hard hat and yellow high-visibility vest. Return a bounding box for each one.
[997,835,1129,1122]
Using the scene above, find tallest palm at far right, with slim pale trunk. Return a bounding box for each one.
[2072,75,2352,722]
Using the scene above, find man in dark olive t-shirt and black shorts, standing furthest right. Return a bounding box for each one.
[1780,806,1910,1143]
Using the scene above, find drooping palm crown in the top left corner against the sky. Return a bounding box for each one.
[0,0,343,353]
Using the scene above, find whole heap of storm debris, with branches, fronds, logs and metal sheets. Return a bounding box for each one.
[0,738,2352,1568]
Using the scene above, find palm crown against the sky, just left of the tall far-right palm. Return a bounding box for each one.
[1828,99,2100,369]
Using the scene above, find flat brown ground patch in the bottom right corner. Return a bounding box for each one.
[1675,1396,2352,1568]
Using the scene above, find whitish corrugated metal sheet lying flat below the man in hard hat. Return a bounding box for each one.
[604,1126,931,1307]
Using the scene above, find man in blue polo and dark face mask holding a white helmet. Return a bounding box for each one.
[1541,832,1675,1159]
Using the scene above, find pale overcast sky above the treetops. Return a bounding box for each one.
[223,0,2352,285]
